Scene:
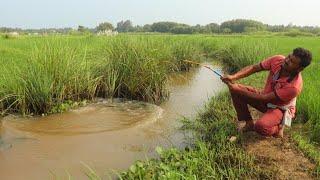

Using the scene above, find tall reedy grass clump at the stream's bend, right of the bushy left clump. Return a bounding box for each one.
[96,39,167,102]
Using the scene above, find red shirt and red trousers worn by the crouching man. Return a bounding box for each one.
[231,55,302,136]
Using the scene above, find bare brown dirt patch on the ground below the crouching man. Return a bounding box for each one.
[243,110,315,180]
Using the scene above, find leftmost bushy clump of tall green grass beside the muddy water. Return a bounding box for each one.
[0,40,98,114]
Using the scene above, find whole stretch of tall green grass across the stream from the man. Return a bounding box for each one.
[0,35,204,114]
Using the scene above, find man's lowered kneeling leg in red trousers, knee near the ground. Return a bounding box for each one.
[254,109,283,136]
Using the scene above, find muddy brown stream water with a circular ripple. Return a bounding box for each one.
[0,64,223,179]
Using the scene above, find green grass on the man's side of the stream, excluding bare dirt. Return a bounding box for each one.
[121,37,320,179]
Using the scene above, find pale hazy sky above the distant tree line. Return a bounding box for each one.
[0,0,320,29]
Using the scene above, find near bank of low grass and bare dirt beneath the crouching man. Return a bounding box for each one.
[121,69,319,179]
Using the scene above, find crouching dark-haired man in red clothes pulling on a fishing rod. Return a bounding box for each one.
[221,48,312,137]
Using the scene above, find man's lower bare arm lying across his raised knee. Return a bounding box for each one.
[227,82,279,103]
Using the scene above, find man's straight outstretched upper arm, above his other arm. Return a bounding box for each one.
[221,63,264,82]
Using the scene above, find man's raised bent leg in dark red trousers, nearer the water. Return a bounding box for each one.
[230,85,267,130]
